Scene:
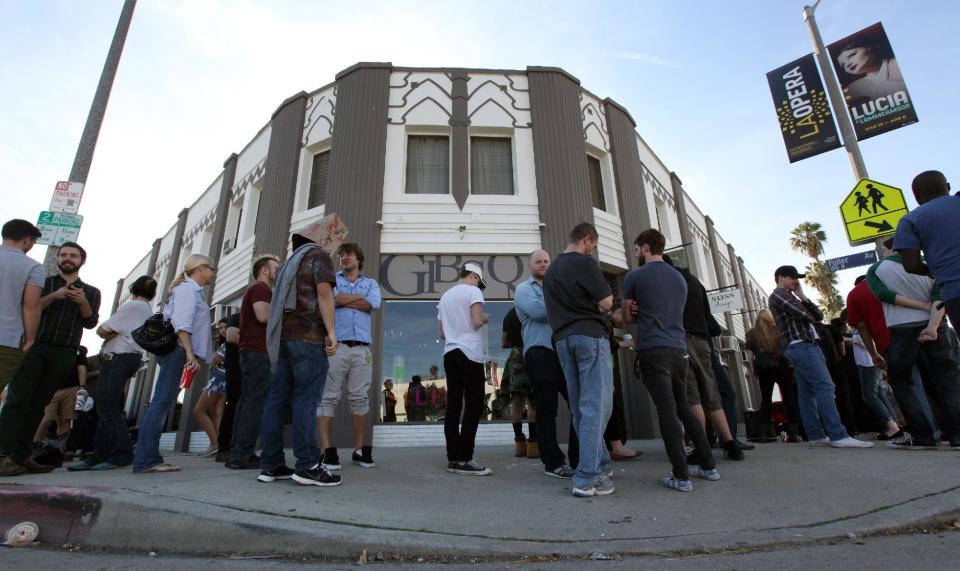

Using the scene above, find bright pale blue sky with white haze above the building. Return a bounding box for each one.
[0,0,960,348]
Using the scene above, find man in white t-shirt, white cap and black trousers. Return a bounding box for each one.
[437,262,493,476]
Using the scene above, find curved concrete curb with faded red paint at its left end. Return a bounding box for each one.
[0,485,960,560]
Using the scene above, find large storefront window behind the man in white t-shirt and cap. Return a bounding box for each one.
[380,300,513,422]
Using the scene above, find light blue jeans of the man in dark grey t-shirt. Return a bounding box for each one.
[557,335,613,488]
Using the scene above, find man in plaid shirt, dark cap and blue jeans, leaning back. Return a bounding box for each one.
[769,266,873,448]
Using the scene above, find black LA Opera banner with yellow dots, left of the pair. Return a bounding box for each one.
[767,54,841,163]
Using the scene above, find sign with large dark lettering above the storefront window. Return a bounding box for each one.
[380,254,527,299]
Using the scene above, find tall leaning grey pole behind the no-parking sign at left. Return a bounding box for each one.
[43,0,137,275]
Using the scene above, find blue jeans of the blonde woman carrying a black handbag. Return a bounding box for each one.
[133,345,187,472]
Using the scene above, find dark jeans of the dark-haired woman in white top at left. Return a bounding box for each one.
[93,353,143,466]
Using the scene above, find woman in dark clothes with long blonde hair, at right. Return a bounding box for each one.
[747,309,800,442]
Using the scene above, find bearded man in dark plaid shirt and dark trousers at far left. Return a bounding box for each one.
[0,242,100,476]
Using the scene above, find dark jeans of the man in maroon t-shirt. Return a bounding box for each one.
[230,351,271,461]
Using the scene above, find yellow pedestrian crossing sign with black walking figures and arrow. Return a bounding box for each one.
[840,178,908,246]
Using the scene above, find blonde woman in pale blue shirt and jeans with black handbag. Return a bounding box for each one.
[133,254,216,474]
